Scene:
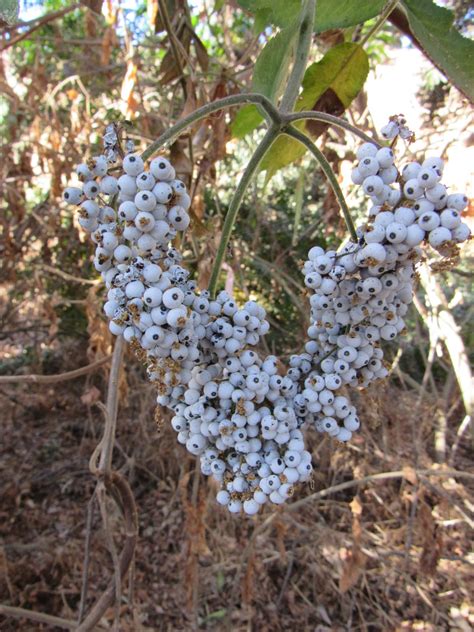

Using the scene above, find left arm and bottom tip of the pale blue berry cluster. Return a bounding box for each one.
[64,142,312,514]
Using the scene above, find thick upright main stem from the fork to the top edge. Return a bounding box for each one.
[280,0,316,114]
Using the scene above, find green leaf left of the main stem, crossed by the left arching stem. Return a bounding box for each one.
[231,21,298,138]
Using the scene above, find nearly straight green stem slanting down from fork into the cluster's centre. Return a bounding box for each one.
[209,124,280,296]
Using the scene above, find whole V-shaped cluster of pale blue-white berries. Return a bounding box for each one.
[64,121,467,515]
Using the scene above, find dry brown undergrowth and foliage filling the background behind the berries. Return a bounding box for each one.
[0,0,474,630]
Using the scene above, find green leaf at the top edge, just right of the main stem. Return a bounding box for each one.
[314,0,386,33]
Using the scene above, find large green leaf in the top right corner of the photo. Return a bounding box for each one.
[403,0,474,102]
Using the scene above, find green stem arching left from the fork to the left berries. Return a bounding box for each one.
[142,93,281,160]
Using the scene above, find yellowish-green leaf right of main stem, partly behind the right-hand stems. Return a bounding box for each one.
[261,42,369,182]
